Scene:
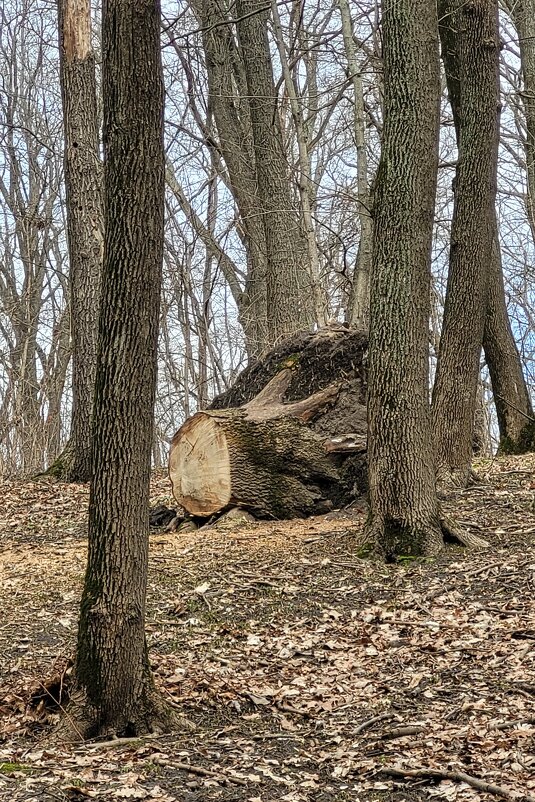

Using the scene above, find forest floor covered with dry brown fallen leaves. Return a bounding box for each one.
[0,455,535,802]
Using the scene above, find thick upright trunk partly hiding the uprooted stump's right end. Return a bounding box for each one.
[368,0,442,560]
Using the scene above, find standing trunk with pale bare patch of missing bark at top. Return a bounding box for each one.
[56,0,103,482]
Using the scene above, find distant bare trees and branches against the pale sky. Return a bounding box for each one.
[0,0,535,475]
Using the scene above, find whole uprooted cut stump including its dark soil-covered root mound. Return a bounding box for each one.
[169,328,367,518]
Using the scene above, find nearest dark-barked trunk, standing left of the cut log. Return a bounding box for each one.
[75,0,172,736]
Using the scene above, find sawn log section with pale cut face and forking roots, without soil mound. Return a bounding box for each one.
[169,368,352,518]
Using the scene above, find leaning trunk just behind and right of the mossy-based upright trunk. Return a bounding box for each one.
[433,0,499,486]
